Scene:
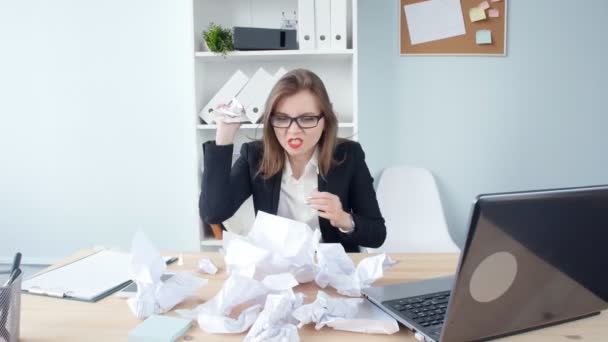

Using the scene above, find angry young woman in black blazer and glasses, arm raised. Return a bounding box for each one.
[199,69,386,252]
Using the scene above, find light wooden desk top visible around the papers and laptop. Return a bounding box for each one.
[20,252,608,342]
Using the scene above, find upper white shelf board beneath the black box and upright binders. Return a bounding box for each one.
[194,49,353,62]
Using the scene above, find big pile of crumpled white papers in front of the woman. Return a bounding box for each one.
[178,211,399,341]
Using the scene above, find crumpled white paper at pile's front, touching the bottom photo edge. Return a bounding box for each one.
[245,290,304,342]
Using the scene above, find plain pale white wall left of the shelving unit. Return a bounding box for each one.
[0,0,198,262]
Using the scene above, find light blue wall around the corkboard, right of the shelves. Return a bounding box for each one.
[359,0,608,244]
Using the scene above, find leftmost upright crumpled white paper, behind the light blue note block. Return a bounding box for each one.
[127,232,208,319]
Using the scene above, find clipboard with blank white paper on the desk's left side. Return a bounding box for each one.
[21,250,177,302]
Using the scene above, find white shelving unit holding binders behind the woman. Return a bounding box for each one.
[192,0,358,249]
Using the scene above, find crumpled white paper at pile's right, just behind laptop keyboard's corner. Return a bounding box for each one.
[315,243,396,297]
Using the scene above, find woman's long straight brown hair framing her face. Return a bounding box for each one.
[258,69,338,179]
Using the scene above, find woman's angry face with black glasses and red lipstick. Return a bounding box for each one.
[271,90,325,156]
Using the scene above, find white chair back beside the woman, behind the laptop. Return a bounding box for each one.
[370,166,460,253]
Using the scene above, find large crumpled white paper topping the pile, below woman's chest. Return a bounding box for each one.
[223,211,320,283]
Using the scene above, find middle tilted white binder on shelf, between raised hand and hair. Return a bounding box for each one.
[236,68,275,123]
